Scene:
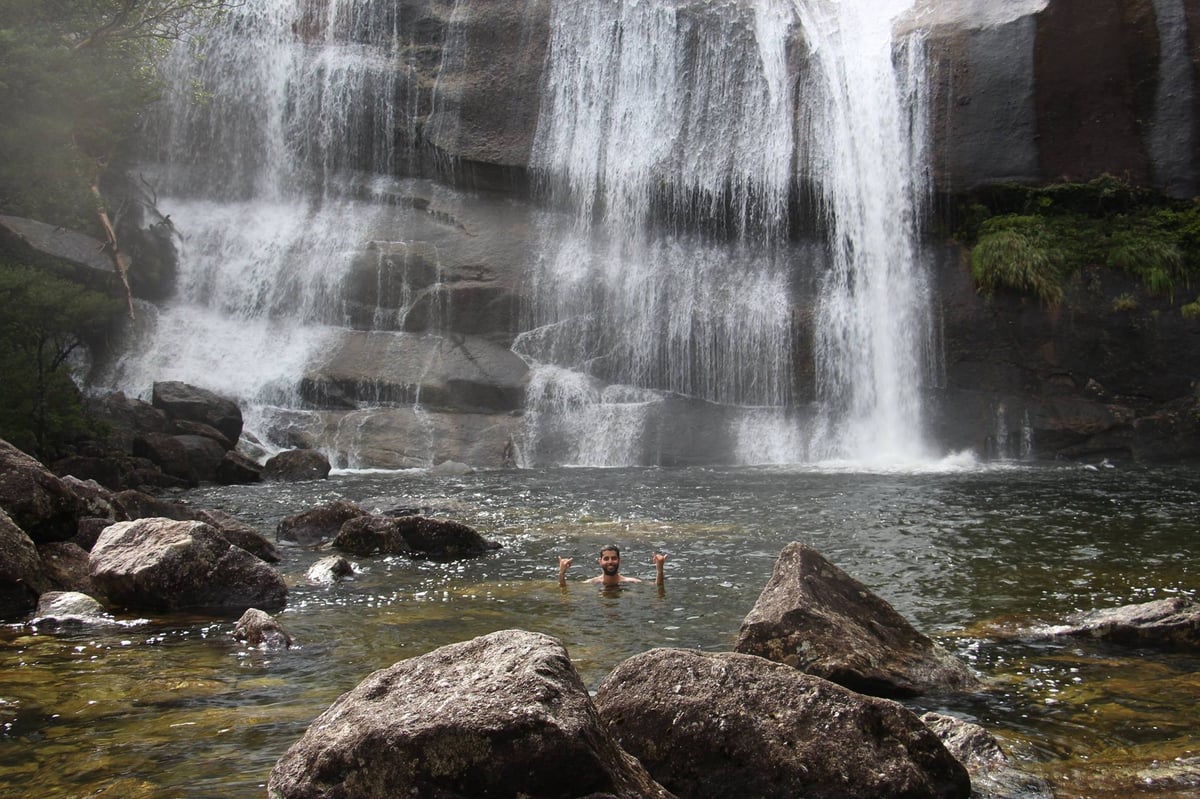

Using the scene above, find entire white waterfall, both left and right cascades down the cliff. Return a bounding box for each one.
[102,0,932,465]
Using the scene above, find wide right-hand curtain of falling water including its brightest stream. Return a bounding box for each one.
[516,0,931,465]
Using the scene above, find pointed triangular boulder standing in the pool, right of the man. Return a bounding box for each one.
[734,542,978,697]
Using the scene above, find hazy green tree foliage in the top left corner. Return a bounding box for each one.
[0,0,226,233]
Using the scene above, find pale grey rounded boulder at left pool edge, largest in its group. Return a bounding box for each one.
[90,518,288,613]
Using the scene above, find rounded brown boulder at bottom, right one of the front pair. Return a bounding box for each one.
[595,649,971,799]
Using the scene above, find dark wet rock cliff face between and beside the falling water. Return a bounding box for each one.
[105,0,1200,467]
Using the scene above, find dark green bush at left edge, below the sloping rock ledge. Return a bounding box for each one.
[0,264,122,459]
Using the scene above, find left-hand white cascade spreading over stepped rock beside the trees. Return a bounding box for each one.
[102,0,410,458]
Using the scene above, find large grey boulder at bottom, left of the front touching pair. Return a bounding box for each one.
[268,630,671,799]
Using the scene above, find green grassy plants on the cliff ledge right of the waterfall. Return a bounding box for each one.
[959,178,1200,305]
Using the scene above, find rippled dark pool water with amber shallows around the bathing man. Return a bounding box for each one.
[0,463,1200,799]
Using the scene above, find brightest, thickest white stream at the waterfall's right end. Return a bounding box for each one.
[797,0,932,459]
